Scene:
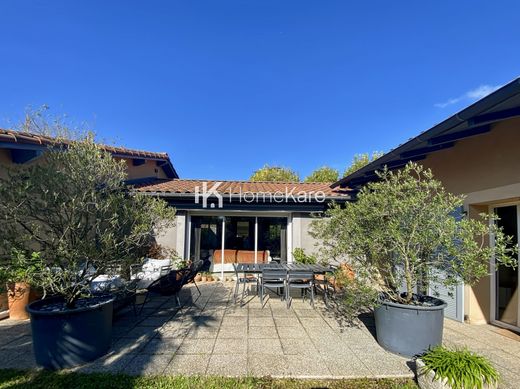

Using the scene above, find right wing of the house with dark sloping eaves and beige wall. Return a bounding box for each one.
[333,78,520,331]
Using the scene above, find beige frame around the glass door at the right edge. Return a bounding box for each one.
[488,201,520,331]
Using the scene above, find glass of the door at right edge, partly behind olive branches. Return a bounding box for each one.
[493,205,520,327]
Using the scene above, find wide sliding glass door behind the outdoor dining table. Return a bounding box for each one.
[189,215,288,271]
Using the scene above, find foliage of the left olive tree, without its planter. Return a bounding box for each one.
[0,135,175,307]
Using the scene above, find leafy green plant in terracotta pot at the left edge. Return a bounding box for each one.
[0,248,42,320]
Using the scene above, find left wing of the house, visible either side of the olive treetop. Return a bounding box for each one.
[0,129,179,184]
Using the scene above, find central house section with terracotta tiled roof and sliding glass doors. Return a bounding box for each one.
[136,179,351,276]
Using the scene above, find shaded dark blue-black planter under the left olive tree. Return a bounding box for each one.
[27,297,114,370]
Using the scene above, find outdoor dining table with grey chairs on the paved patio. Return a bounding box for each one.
[233,262,334,308]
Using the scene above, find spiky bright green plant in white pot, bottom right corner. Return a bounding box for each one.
[416,346,500,389]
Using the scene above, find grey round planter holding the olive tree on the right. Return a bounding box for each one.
[374,296,447,357]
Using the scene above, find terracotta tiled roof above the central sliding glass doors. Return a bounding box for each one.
[135,179,350,198]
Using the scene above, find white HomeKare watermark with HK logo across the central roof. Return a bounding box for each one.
[195,181,327,208]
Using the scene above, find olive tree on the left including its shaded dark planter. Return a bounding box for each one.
[0,135,175,369]
